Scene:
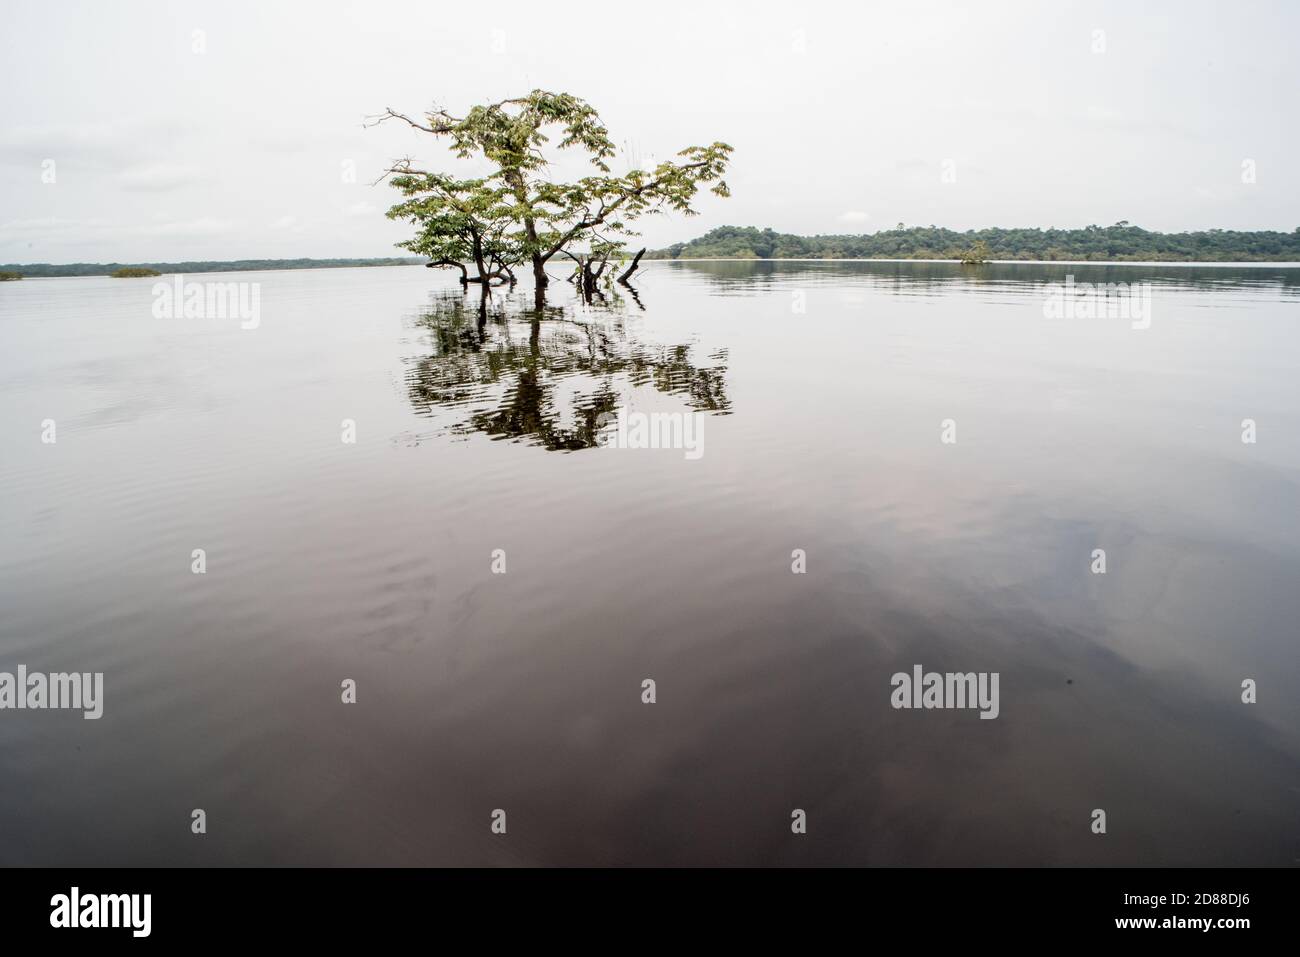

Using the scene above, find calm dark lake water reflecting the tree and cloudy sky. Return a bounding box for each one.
[0,263,1300,865]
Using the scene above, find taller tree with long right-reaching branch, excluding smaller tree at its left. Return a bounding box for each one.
[372,90,732,293]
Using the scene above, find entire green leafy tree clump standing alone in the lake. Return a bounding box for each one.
[372,90,732,294]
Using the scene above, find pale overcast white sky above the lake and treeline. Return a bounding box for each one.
[0,0,1300,263]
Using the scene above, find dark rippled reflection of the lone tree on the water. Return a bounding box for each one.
[407,293,731,451]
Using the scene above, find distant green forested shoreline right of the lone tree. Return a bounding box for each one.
[646,222,1300,263]
